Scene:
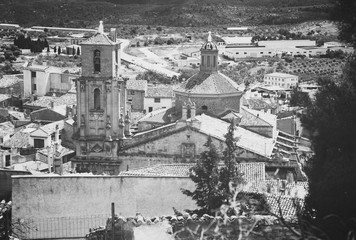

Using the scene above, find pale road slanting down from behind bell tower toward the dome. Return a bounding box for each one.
[119,39,180,77]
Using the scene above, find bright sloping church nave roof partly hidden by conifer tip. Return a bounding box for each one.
[196,114,275,158]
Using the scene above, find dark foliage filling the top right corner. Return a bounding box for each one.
[331,0,356,47]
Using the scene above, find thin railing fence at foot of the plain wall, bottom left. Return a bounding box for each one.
[13,215,110,239]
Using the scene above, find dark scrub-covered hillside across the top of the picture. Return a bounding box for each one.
[0,0,330,27]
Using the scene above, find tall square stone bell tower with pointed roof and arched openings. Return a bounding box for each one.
[73,21,130,174]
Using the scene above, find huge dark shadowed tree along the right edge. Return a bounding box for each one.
[302,55,356,239]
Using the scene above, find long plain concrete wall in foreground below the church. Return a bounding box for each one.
[12,176,196,238]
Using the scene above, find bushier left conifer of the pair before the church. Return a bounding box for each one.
[182,136,222,215]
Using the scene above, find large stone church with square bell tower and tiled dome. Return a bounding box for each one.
[69,25,294,180]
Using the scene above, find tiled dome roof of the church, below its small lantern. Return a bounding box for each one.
[176,72,240,94]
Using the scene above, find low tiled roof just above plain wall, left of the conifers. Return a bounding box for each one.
[119,164,194,177]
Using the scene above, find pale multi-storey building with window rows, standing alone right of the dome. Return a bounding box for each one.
[263,72,298,89]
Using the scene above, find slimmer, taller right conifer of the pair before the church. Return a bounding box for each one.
[219,119,243,204]
